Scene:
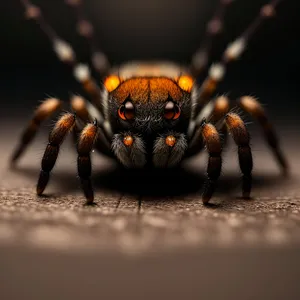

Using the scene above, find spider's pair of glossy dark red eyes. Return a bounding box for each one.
[118,100,181,121]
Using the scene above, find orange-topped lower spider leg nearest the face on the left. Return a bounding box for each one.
[77,121,99,204]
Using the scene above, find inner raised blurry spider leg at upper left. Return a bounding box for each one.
[65,0,109,76]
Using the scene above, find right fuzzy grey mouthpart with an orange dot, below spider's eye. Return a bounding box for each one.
[153,132,187,168]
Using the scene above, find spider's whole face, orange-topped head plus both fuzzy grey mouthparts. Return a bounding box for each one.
[105,70,192,167]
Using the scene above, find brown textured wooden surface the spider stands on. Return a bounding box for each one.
[0,122,300,299]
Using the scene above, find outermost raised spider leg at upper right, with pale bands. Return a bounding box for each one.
[195,0,282,116]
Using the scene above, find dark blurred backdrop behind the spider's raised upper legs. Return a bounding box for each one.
[0,0,300,122]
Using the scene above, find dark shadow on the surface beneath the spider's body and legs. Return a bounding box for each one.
[13,157,284,200]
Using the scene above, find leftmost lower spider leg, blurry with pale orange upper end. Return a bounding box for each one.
[11,98,62,165]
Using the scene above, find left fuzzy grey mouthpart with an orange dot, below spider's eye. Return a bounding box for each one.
[111,132,146,168]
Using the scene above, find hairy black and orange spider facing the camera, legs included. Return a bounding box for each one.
[11,0,288,204]
